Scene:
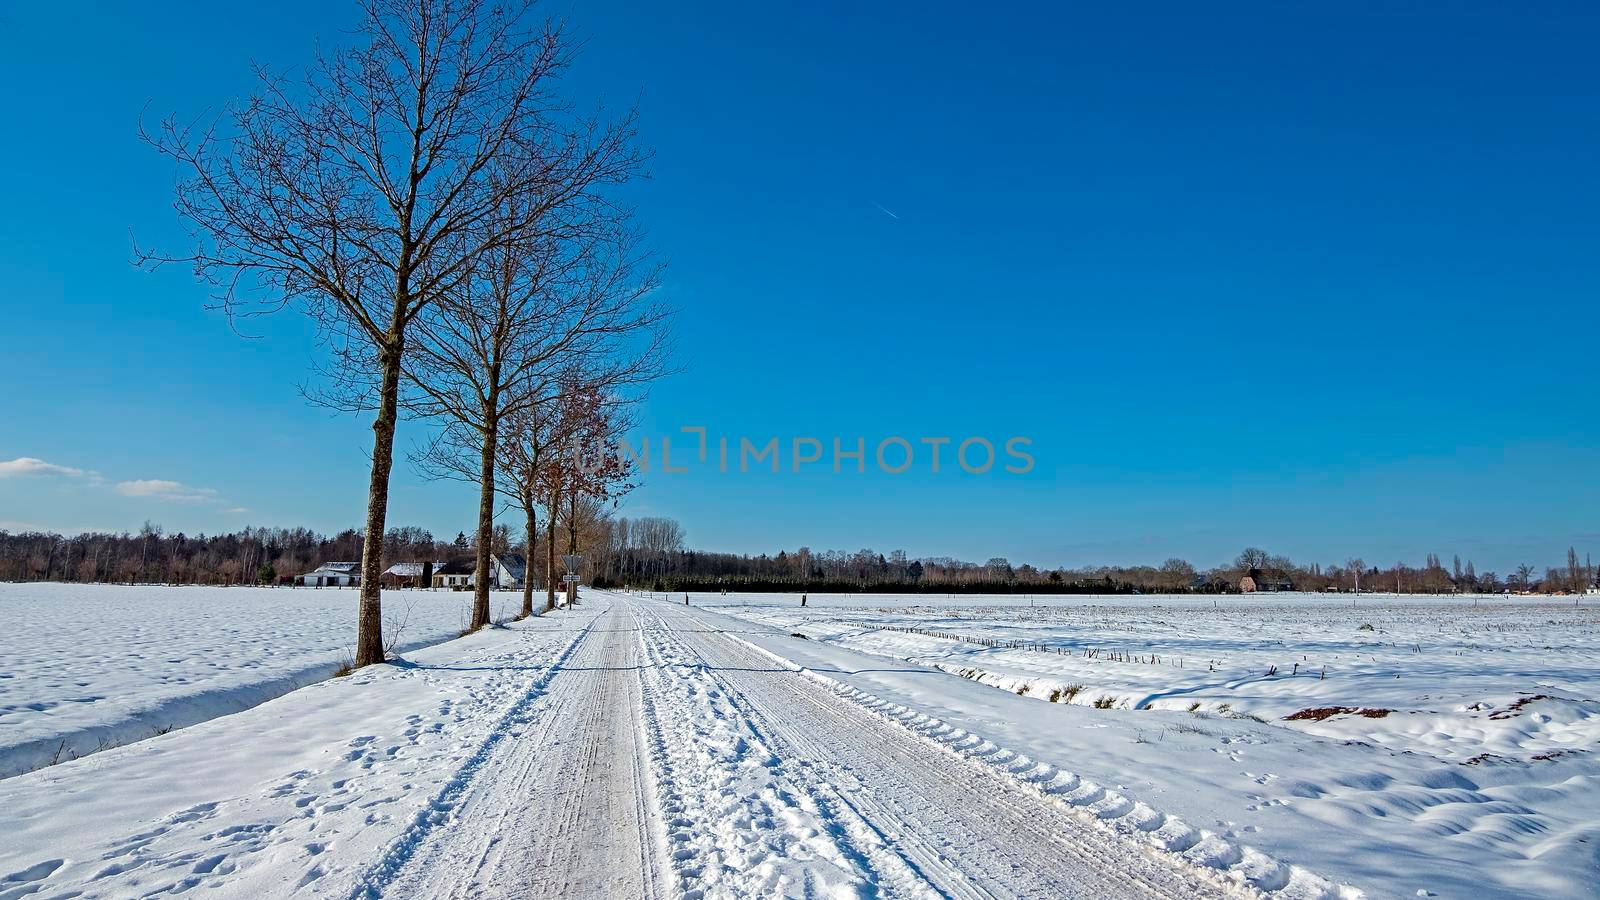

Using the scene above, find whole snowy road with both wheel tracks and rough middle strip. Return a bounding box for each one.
[368,596,1216,900]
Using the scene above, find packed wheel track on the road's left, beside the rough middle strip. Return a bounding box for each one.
[370,607,666,900]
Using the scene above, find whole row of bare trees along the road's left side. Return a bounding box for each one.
[136,0,669,666]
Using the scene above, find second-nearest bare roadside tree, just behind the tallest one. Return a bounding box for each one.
[403,193,667,628]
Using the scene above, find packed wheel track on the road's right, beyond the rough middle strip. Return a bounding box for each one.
[634,589,1235,897]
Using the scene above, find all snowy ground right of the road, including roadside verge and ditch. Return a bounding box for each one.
[694,594,1600,897]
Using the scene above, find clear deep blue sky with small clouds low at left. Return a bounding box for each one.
[0,2,1600,570]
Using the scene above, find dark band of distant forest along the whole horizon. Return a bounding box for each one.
[0,508,1597,594]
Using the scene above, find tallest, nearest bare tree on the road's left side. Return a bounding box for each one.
[134,0,634,666]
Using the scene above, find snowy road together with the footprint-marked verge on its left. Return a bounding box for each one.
[0,591,1260,900]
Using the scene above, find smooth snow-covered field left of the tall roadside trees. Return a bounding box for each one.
[0,583,520,778]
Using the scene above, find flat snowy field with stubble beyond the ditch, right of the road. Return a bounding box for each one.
[694,594,1600,764]
